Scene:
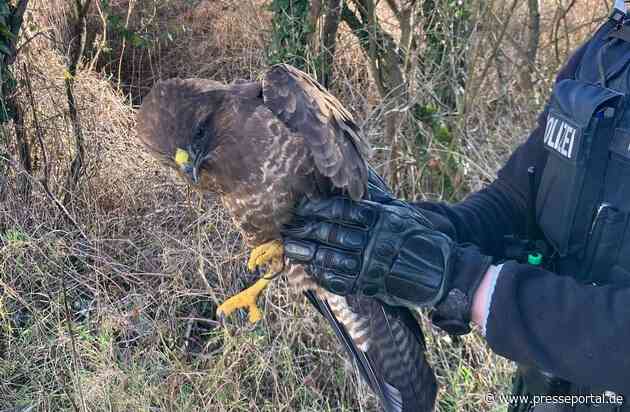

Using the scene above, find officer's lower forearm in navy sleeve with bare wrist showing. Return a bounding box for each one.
[472,262,630,393]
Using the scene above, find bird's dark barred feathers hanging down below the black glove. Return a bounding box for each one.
[304,290,437,412]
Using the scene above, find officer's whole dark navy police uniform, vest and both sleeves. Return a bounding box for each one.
[418,2,630,411]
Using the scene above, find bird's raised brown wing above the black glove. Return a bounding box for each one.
[262,64,369,200]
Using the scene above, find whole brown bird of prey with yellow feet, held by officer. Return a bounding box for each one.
[137,64,437,412]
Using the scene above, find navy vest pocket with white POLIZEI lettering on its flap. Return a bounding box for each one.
[536,79,622,257]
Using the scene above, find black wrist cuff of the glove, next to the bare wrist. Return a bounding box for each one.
[431,246,492,335]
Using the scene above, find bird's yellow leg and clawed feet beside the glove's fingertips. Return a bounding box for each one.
[217,240,284,323]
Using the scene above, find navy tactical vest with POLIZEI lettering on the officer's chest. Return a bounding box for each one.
[510,10,630,412]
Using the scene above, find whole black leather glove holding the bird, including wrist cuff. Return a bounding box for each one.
[283,191,491,334]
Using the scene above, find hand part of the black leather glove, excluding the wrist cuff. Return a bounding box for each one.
[285,198,452,306]
